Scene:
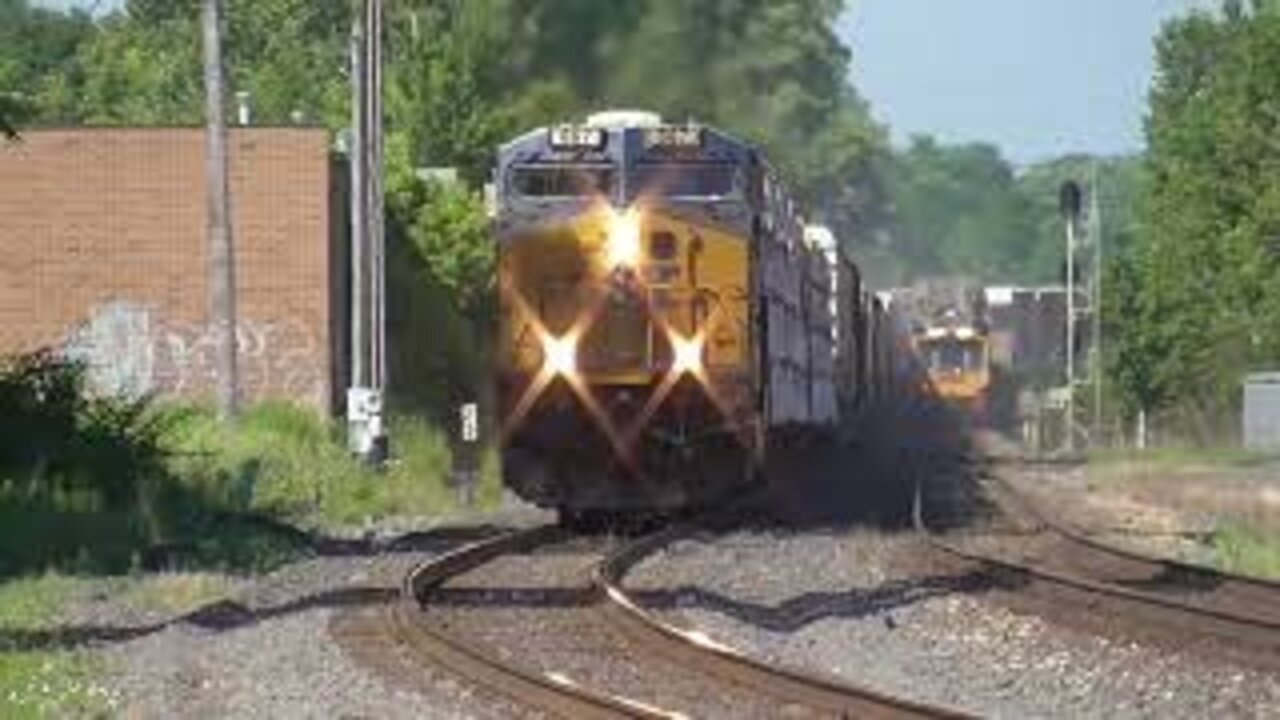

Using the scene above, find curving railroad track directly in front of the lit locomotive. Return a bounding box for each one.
[393,517,961,717]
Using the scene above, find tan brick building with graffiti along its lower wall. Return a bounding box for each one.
[0,128,347,410]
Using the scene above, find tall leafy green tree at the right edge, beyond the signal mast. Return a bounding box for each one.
[1110,5,1280,430]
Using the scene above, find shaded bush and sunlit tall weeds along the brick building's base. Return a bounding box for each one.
[0,356,500,578]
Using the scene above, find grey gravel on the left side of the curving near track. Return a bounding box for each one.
[67,502,544,720]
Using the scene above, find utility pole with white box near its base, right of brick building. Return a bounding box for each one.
[347,0,388,464]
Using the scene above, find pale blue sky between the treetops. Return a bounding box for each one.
[841,0,1220,164]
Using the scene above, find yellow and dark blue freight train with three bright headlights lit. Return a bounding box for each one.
[494,111,892,515]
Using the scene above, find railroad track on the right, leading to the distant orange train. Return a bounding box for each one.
[914,471,1280,670]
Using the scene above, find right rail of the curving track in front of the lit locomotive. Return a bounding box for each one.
[594,527,969,719]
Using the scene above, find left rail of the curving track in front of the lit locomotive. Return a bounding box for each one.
[389,525,676,720]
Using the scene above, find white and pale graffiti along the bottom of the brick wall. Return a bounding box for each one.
[65,301,328,407]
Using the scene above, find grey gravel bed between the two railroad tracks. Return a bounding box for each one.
[627,532,1280,717]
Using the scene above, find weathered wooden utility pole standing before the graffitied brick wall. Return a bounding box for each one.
[201,0,239,420]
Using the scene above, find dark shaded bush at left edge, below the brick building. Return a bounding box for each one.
[0,356,307,577]
